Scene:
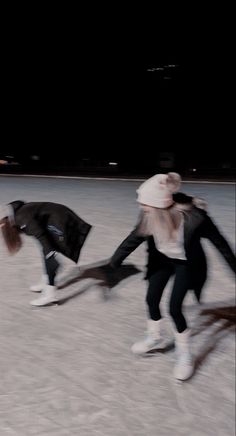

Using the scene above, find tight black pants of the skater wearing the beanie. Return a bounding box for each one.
[146,257,189,333]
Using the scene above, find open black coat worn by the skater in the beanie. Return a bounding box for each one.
[110,193,236,301]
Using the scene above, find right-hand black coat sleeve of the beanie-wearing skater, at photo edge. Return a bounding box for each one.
[201,215,236,273]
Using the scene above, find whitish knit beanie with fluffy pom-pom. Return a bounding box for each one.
[137,173,181,209]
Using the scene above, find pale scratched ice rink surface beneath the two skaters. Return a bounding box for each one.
[0,176,235,436]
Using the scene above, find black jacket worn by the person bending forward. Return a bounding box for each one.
[10,201,92,262]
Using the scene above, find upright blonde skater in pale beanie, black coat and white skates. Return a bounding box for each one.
[107,173,236,380]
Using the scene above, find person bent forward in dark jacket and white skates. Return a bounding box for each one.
[0,201,92,306]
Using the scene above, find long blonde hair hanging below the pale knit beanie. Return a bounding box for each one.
[138,205,181,242]
